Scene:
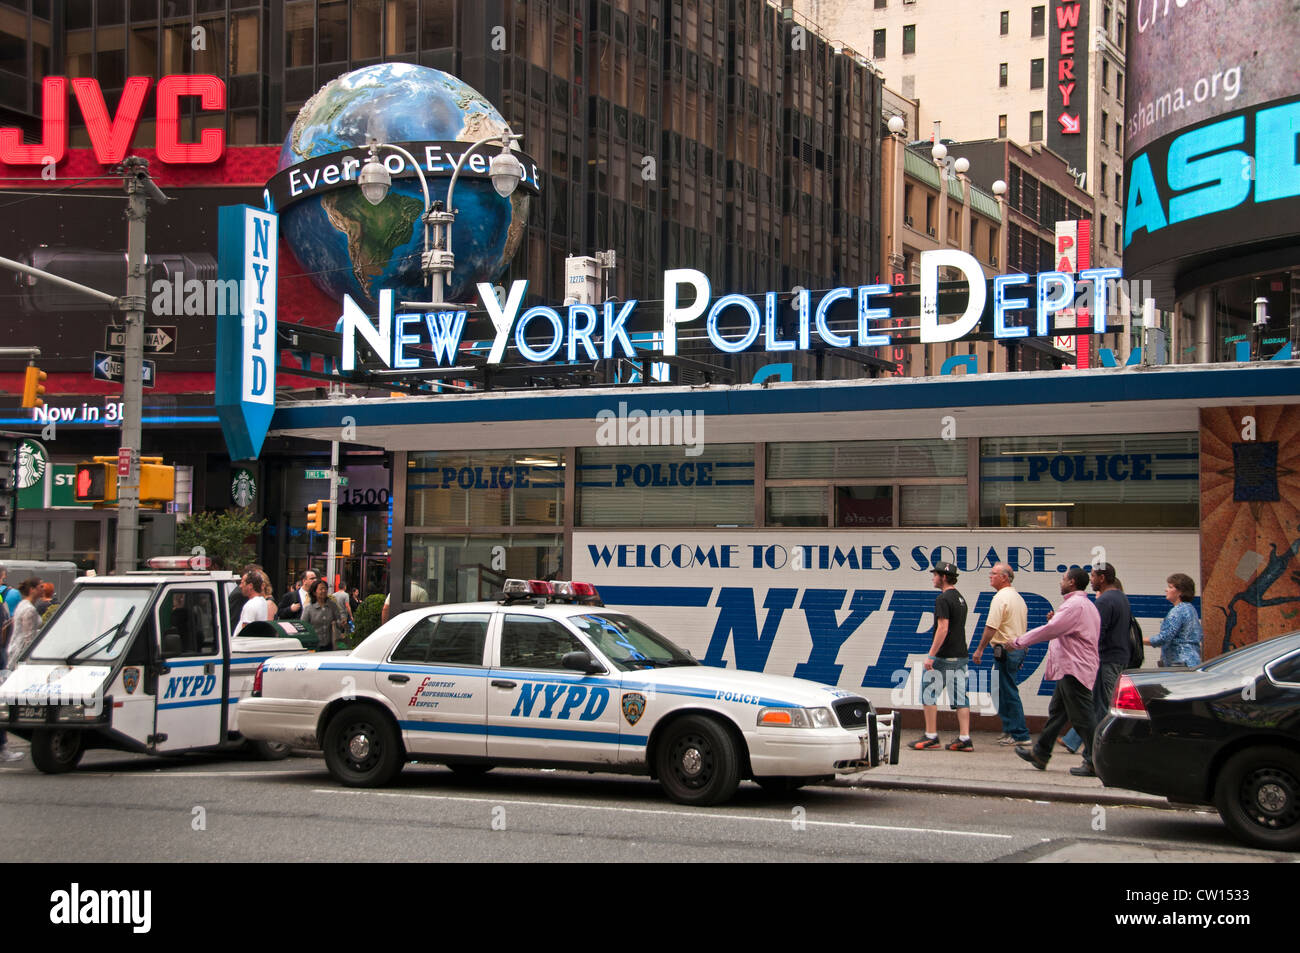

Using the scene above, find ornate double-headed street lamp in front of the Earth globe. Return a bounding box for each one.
[356,129,524,304]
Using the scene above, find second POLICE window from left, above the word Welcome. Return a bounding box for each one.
[577,439,754,527]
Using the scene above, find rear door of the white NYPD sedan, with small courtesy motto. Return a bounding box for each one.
[376,612,491,757]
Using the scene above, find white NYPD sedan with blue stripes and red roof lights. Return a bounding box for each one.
[239,580,898,805]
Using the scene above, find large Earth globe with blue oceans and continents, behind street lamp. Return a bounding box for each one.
[278,62,528,311]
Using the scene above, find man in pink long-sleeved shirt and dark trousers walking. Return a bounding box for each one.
[1011,568,1101,777]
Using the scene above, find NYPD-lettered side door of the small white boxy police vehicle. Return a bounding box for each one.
[153,582,226,751]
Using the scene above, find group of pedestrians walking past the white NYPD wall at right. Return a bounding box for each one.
[910,563,1204,777]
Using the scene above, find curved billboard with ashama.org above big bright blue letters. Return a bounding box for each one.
[1123,0,1300,299]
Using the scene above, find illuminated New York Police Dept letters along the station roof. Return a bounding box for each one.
[341,248,1121,372]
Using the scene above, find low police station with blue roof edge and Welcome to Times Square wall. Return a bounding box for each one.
[273,360,1300,714]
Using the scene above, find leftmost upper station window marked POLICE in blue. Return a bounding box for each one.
[407,450,564,527]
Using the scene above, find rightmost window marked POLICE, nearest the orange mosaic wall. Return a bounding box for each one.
[980,433,1200,529]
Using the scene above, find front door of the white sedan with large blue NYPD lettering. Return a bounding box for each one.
[488,612,619,763]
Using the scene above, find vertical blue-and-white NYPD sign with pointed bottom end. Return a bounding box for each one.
[216,205,280,460]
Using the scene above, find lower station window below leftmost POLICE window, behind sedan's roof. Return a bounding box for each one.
[403,532,564,603]
